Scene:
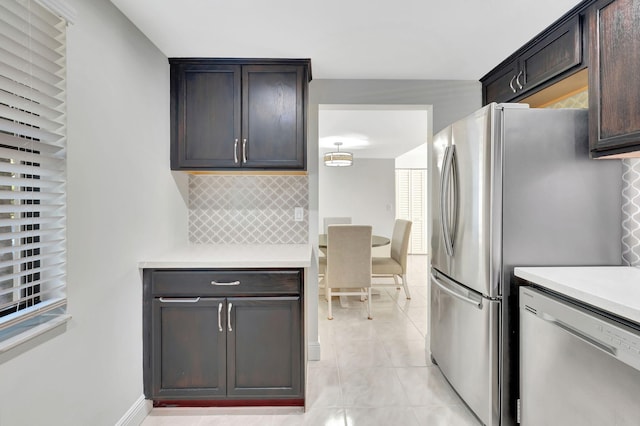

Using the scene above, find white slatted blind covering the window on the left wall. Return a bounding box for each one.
[0,0,66,340]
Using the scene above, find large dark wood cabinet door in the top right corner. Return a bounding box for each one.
[588,0,640,157]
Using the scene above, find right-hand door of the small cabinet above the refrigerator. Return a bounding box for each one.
[520,15,582,90]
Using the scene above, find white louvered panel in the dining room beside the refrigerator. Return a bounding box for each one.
[396,169,427,254]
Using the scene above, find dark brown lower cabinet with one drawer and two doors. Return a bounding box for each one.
[144,270,304,406]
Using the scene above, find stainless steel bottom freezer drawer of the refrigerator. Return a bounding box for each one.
[430,269,501,426]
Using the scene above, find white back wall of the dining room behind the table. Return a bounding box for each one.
[318,157,395,237]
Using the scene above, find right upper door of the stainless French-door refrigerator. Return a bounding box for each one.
[441,104,501,297]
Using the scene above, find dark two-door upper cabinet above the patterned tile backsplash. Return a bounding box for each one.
[169,58,311,171]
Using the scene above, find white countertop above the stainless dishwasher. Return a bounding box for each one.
[514,266,640,324]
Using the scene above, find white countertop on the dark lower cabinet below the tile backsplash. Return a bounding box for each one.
[138,244,311,268]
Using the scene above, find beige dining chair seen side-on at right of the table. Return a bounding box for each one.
[371,219,411,299]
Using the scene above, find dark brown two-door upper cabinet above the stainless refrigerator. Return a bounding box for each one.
[480,13,586,105]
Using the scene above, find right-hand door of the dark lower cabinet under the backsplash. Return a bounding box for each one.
[227,296,303,398]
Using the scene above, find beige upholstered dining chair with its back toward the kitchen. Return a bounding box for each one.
[324,225,373,320]
